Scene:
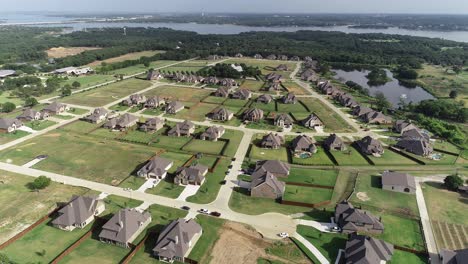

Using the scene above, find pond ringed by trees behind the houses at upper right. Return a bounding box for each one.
[332,69,434,107]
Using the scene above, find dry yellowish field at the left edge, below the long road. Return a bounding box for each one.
[0,171,88,243]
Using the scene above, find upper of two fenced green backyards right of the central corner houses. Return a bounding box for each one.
[280,167,338,186]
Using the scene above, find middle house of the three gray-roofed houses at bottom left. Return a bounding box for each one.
[99,208,151,248]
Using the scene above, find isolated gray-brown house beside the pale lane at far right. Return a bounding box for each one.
[382,171,416,193]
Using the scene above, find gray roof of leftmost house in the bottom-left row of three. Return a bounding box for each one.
[52,196,102,226]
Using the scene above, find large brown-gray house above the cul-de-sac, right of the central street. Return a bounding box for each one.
[250,171,286,199]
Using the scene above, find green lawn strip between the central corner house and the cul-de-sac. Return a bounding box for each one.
[229,188,310,215]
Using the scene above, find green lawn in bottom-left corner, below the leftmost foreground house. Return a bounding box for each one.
[0,219,92,263]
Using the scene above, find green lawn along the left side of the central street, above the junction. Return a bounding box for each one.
[186,159,231,204]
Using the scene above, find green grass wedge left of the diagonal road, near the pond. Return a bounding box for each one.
[301,98,354,133]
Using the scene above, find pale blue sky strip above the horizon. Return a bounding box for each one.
[0,0,468,14]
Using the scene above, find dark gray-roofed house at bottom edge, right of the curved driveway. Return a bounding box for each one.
[344,233,394,264]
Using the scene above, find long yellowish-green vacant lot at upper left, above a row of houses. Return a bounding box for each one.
[60,79,151,107]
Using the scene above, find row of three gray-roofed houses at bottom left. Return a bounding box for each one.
[52,196,202,263]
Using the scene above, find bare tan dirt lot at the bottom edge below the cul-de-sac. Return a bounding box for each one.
[210,222,310,264]
